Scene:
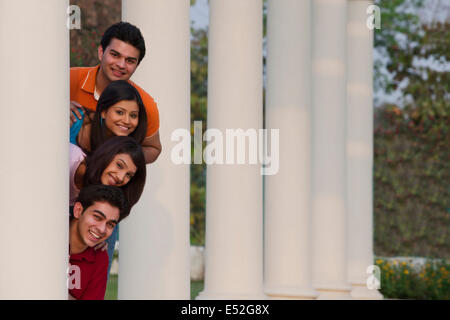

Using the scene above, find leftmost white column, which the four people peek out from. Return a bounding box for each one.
[0,0,69,299]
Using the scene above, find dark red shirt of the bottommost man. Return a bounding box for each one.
[69,247,109,300]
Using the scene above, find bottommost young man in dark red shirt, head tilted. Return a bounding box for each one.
[68,185,128,300]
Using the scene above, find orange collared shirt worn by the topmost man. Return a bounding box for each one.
[70,65,159,137]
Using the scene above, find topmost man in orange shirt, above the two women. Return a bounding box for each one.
[70,22,162,163]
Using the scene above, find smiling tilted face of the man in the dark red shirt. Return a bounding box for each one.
[74,201,119,247]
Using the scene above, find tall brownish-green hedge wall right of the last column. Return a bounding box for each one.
[374,105,450,257]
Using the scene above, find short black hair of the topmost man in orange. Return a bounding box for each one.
[100,22,145,65]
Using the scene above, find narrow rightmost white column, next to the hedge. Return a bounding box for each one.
[347,0,382,299]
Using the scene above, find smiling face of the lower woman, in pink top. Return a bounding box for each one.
[100,153,137,187]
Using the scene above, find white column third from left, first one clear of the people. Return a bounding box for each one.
[198,0,265,299]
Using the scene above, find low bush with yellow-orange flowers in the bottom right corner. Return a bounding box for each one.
[375,258,450,300]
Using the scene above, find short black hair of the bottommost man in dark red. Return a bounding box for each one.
[77,184,129,221]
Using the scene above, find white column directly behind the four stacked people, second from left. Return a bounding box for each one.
[118,0,190,299]
